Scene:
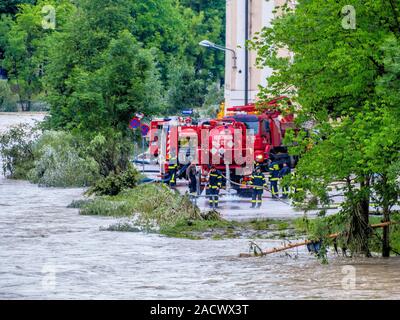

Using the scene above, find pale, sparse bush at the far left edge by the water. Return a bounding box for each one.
[0,123,39,179]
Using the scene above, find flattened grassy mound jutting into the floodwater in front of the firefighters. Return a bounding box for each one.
[78,183,302,240]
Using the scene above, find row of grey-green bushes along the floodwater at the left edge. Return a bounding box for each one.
[0,124,134,188]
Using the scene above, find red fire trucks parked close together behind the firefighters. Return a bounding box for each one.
[150,97,295,195]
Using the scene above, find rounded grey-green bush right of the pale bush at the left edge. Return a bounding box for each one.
[29,131,99,187]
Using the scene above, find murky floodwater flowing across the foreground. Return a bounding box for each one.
[0,114,400,299]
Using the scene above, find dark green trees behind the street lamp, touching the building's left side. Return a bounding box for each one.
[132,0,225,114]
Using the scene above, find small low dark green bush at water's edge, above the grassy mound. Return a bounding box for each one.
[86,167,140,196]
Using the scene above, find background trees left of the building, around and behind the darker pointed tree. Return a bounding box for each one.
[0,0,225,116]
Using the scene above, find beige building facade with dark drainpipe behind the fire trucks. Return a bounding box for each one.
[225,0,294,107]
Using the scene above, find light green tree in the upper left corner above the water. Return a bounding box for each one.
[0,0,71,111]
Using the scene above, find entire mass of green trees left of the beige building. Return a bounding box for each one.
[0,0,224,176]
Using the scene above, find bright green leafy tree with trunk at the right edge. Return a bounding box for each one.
[252,0,400,254]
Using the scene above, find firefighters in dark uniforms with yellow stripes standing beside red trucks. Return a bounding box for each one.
[164,158,291,208]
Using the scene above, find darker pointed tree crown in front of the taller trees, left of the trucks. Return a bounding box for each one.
[60,30,161,132]
